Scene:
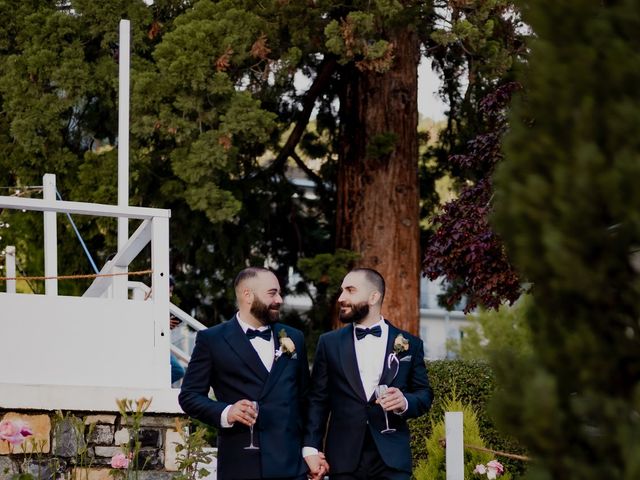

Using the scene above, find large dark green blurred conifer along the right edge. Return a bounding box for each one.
[495,0,640,480]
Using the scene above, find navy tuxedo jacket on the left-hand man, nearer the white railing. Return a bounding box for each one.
[179,318,309,480]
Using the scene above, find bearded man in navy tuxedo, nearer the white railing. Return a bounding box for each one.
[179,267,319,480]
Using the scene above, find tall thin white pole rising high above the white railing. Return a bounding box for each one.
[113,20,131,298]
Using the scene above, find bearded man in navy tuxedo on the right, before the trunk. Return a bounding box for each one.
[303,268,433,480]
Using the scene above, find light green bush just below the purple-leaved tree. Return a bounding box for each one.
[447,295,532,362]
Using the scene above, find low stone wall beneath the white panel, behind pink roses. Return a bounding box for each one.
[0,409,204,480]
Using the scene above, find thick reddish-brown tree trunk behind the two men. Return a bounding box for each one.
[336,26,420,334]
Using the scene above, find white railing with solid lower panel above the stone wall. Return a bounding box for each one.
[0,174,175,400]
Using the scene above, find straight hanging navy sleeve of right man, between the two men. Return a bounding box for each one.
[303,337,329,450]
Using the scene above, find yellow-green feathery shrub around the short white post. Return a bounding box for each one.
[413,392,511,480]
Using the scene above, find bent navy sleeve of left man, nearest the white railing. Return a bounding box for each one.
[178,330,228,428]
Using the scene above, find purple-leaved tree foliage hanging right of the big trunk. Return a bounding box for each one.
[423,83,522,312]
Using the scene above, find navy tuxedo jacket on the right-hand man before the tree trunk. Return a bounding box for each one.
[304,322,433,474]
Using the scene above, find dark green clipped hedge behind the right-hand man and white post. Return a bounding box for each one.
[409,360,526,478]
